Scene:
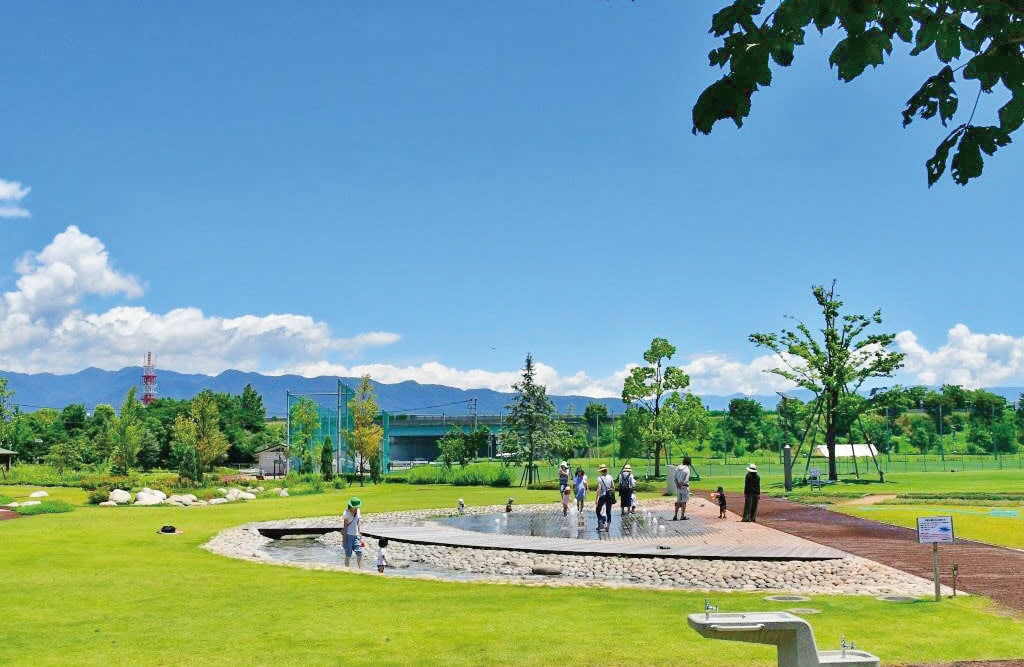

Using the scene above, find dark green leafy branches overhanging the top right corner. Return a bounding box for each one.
[693,0,1024,185]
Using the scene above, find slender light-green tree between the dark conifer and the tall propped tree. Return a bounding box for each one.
[623,338,690,477]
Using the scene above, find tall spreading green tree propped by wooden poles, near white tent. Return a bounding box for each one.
[750,281,903,480]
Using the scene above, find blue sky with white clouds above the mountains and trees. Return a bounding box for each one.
[0,0,1024,394]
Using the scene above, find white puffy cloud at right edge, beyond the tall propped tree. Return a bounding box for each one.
[896,324,1024,388]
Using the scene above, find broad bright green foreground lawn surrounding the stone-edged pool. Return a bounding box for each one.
[0,485,1024,667]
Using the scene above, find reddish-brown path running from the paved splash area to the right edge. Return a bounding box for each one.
[729,494,1024,614]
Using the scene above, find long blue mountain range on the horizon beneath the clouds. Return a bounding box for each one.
[0,366,1024,417]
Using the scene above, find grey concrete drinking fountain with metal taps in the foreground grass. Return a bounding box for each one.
[686,602,880,667]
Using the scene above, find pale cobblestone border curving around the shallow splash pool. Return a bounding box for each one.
[203,505,951,597]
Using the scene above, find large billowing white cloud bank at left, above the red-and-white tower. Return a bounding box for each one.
[0,225,399,374]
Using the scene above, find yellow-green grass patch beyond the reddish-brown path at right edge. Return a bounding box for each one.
[833,504,1024,549]
